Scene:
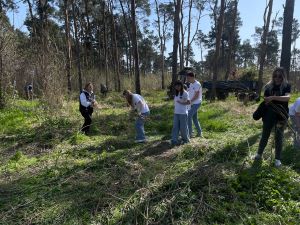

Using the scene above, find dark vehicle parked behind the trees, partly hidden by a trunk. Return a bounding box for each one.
[202,80,259,101]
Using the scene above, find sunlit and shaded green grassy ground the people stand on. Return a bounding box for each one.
[0,92,300,225]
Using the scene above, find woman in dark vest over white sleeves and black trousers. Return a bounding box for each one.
[79,83,96,135]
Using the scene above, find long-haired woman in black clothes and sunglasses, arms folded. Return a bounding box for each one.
[255,67,291,167]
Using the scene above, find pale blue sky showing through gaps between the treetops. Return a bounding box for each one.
[8,0,300,60]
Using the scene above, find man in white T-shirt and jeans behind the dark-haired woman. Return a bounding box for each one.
[187,72,202,137]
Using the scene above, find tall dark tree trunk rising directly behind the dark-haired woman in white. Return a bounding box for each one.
[172,0,181,86]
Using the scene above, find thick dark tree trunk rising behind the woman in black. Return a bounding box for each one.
[280,0,295,79]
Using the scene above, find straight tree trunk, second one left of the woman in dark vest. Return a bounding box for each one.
[64,0,72,94]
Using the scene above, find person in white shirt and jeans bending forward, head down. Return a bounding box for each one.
[123,90,150,143]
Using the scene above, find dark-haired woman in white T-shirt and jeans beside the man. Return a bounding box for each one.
[171,81,190,145]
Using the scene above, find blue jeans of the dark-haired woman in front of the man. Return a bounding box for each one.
[172,114,189,144]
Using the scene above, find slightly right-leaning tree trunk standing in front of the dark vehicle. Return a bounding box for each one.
[211,0,225,101]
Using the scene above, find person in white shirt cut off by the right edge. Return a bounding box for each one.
[289,97,300,148]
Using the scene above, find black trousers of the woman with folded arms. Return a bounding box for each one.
[257,111,286,160]
